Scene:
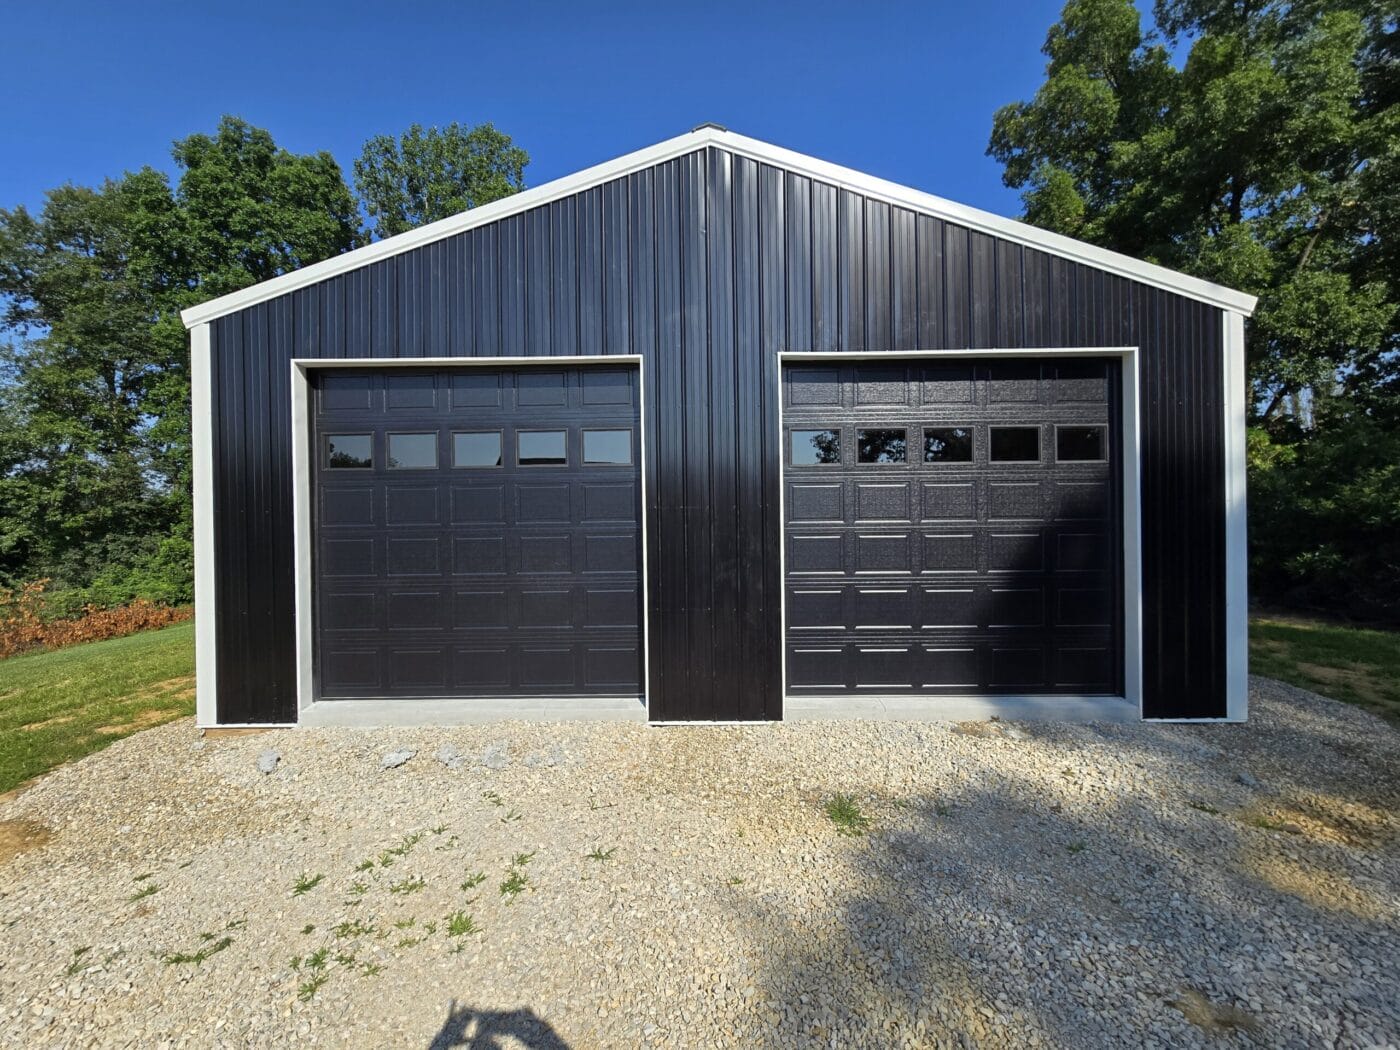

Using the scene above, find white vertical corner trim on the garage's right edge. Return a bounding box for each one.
[1222,312,1249,722]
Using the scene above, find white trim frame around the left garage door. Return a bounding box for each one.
[292,354,651,725]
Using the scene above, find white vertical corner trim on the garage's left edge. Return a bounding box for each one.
[189,325,218,727]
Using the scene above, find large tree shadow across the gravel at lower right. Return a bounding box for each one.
[749,691,1400,1049]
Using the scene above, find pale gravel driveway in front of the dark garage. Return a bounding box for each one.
[0,679,1400,1049]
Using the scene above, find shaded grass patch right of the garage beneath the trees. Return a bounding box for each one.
[1249,617,1400,724]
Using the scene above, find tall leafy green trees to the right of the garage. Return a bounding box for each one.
[988,0,1400,616]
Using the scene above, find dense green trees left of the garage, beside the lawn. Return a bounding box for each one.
[0,118,358,601]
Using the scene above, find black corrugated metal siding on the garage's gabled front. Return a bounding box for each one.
[211,150,1225,722]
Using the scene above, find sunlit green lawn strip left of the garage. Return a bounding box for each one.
[0,623,195,791]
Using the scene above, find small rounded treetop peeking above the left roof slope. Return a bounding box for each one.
[354,122,529,238]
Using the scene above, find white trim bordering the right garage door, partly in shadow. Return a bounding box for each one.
[776,346,1142,718]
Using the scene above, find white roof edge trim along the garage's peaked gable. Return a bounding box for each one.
[181,127,1257,328]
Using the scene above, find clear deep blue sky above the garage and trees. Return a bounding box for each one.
[0,0,1061,214]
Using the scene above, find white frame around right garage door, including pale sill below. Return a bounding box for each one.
[776,346,1142,721]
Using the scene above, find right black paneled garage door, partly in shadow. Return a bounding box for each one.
[783,358,1123,696]
